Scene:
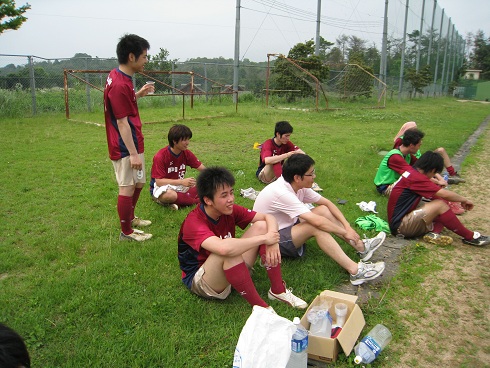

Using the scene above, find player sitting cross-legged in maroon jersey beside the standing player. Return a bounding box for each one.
[150,124,205,210]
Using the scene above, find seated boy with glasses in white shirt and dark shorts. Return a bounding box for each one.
[253,154,386,285]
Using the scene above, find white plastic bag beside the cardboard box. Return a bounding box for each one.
[233,305,296,368]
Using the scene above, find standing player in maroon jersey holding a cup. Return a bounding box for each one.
[104,34,154,241]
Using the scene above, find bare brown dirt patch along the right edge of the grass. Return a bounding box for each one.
[339,117,490,367]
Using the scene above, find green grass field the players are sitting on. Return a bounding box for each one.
[0,99,488,367]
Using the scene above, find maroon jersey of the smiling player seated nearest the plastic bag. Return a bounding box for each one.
[178,203,256,289]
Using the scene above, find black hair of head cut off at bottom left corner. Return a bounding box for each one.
[0,323,31,368]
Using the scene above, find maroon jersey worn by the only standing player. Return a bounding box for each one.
[104,69,145,160]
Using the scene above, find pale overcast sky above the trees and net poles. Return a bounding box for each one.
[0,0,490,64]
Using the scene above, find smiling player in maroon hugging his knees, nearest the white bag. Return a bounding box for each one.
[178,167,308,309]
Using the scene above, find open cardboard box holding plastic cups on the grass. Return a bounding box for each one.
[301,290,366,363]
